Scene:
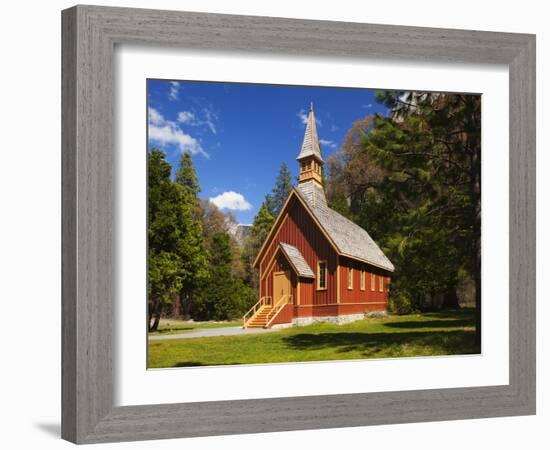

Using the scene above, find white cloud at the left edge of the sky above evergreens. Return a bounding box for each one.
[148,108,209,158]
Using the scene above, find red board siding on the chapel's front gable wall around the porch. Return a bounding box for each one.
[260,197,338,305]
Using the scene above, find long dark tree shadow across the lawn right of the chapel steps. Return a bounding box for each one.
[283,330,480,356]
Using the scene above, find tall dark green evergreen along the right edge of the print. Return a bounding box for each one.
[374,92,481,343]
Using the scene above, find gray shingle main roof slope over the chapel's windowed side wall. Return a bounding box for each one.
[295,185,394,272]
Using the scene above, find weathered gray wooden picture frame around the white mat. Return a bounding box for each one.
[62,6,535,443]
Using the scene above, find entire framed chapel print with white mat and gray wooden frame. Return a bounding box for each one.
[62,6,535,443]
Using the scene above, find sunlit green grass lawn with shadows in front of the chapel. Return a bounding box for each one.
[148,308,480,368]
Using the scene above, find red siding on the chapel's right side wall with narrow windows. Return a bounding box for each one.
[340,257,390,304]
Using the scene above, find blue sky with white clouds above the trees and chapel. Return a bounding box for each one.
[148,80,387,223]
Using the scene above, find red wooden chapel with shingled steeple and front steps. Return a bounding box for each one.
[244,106,394,328]
